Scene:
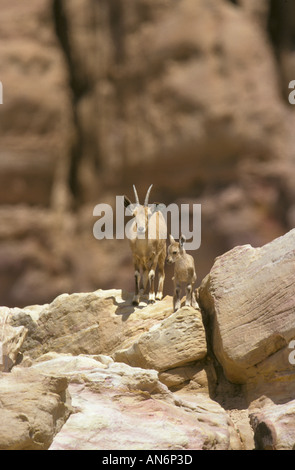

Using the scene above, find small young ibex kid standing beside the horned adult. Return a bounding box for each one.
[167,235,198,312]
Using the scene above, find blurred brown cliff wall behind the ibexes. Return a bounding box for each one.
[0,0,295,306]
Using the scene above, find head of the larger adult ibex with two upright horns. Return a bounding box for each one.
[124,184,154,235]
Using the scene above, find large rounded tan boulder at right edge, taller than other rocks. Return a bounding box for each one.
[199,229,295,398]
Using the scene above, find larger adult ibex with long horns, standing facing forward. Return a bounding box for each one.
[124,185,167,305]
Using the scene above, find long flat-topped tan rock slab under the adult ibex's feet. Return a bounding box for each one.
[10,289,172,358]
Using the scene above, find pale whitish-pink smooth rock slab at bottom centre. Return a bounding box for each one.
[27,355,240,450]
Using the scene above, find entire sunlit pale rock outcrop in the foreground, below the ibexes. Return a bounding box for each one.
[0,230,295,450]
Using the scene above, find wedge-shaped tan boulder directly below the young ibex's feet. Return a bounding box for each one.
[114,307,207,371]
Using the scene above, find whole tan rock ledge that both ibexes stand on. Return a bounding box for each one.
[11,289,215,392]
